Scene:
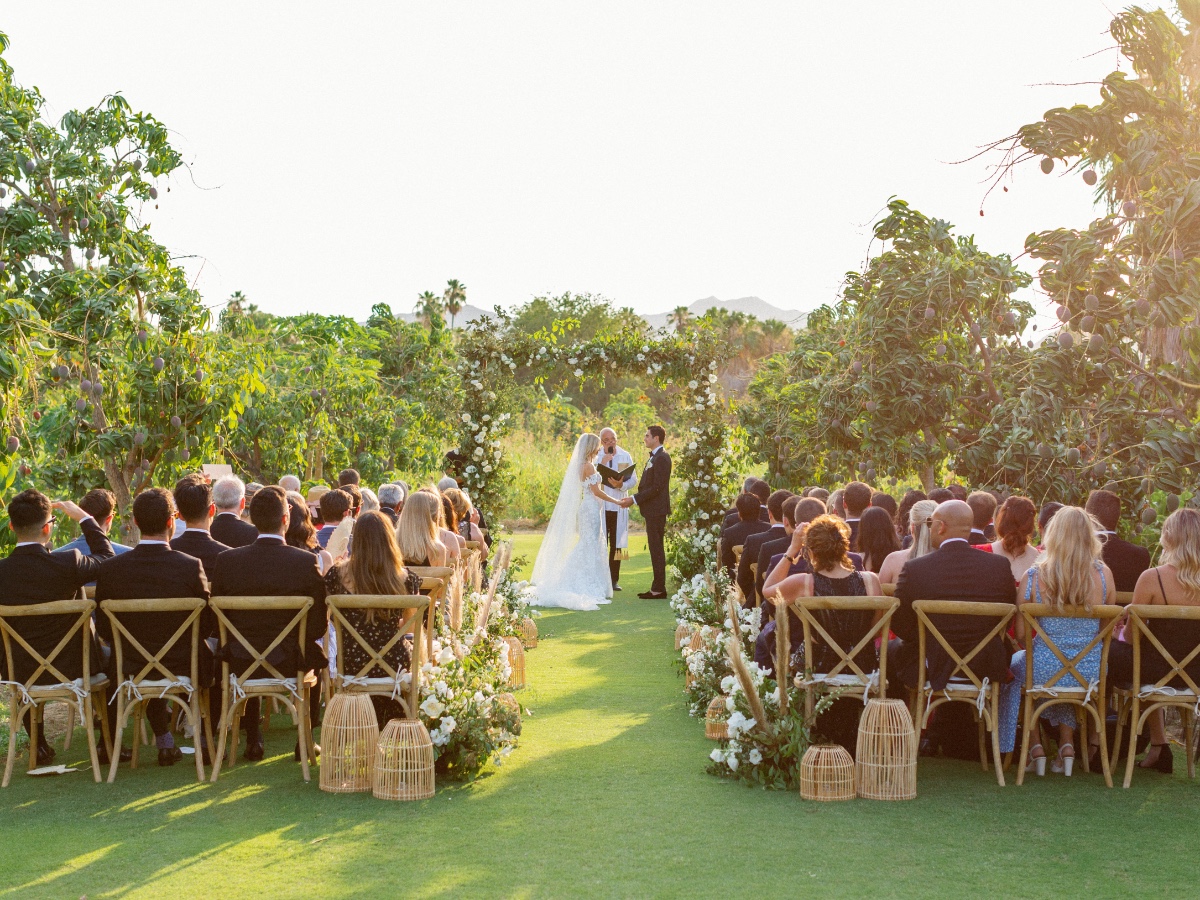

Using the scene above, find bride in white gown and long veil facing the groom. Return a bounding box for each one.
[533,433,612,610]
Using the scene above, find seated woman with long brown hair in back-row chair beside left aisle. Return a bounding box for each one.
[325,512,421,722]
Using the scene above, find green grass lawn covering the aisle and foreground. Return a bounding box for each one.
[0,536,1200,899]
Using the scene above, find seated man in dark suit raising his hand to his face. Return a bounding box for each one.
[0,490,113,764]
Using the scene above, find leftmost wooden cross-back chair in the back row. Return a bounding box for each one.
[0,600,116,787]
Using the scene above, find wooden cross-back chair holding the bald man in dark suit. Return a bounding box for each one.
[912,600,1017,787]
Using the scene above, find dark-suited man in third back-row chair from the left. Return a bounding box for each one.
[210,486,328,760]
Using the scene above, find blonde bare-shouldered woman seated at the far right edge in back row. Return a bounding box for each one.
[1104,509,1200,775]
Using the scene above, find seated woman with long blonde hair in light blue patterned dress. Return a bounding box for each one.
[1000,506,1116,775]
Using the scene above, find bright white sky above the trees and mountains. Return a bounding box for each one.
[0,0,1137,318]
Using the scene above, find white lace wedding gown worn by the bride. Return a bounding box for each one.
[534,472,612,610]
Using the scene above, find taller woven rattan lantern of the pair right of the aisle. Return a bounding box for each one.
[854,700,917,800]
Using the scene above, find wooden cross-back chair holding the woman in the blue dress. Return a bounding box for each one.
[1016,604,1124,787]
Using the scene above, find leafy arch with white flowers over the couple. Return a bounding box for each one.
[458,310,734,577]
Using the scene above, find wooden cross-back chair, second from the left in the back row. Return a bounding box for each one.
[100,596,212,784]
